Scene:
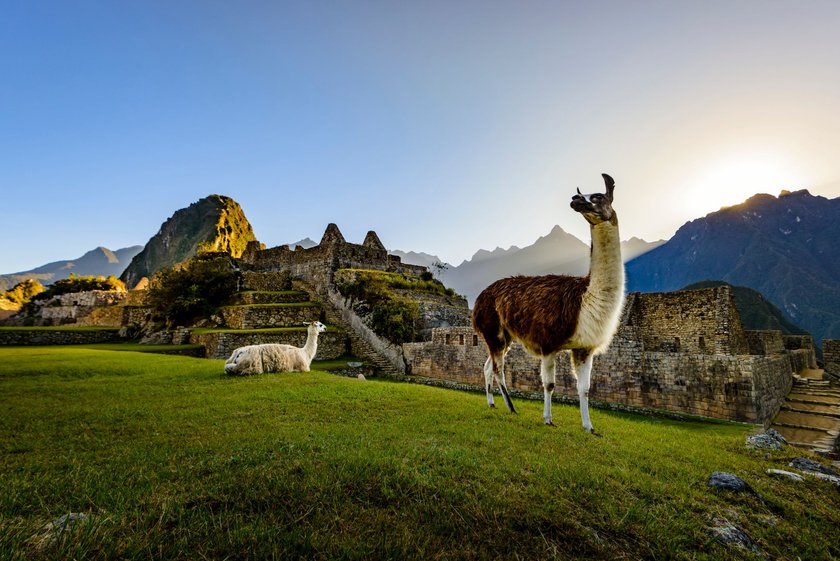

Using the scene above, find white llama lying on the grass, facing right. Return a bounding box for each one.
[225,321,327,375]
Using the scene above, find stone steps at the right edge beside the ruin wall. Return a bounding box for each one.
[770,370,840,456]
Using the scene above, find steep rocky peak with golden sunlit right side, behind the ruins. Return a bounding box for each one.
[120,195,256,288]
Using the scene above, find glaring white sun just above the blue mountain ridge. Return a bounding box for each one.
[685,152,805,212]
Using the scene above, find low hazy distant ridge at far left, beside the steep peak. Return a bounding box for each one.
[0,245,143,291]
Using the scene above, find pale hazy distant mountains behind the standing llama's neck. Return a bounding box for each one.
[391,226,665,305]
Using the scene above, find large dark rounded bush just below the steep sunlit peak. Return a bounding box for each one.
[146,254,238,326]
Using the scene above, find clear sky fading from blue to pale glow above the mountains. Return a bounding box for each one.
[0,0,840,273]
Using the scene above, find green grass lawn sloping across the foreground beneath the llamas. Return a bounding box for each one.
[0,347,840,560]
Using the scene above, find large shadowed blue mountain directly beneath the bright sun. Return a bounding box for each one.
[627,190,840,344]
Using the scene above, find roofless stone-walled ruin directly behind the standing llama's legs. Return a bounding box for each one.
[403,286,816,423]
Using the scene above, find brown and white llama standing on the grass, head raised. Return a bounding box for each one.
[473,173,624,434]
